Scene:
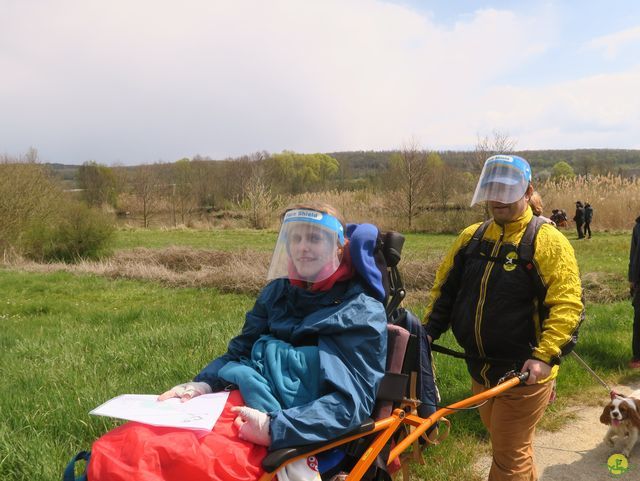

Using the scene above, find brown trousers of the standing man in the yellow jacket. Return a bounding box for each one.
[472,380,553,481]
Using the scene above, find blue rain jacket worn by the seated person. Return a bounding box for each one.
[194,278,387,450]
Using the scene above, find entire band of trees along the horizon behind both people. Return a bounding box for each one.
[67,132,640,229]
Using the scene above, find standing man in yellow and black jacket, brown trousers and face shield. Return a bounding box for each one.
[425,155,583,481]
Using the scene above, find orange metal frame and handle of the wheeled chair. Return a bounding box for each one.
[260,377,521,481]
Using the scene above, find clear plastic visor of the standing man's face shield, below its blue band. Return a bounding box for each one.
[471,164,529,206]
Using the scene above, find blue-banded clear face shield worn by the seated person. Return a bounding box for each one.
[267,209,344,282]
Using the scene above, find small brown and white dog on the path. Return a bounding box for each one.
[600,390,640,457]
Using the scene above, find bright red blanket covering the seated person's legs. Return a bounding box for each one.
[88,391,267,481]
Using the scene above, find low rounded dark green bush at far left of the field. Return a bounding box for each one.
[20,202,115,262]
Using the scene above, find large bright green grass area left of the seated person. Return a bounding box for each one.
[0,271,253,481]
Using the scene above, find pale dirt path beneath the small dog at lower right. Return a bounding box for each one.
[478,385,640,481]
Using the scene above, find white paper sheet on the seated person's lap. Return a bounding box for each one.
[89,392,229,431]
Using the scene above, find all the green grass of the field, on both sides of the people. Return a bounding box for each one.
[0,230,640,481]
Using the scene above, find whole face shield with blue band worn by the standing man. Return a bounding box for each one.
[471,155,531,206]
